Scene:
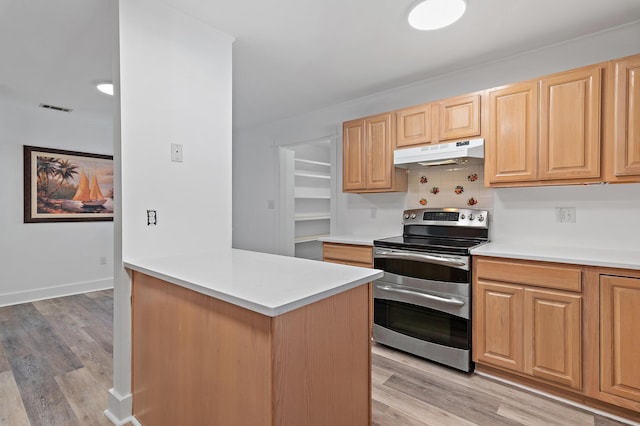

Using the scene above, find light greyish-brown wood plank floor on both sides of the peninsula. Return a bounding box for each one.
[0,291,632,426]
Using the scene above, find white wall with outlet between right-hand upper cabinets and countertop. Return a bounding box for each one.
[491,183,640,250]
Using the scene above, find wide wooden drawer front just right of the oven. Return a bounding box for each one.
[476,259,582,292]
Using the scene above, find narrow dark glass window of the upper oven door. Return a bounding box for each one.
[374,258,471,283]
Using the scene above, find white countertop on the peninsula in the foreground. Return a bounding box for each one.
[124,248,382,317]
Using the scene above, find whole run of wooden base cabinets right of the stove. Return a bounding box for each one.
[473,256,640,421]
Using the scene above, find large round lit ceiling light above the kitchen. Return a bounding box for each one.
[408,0,467,30]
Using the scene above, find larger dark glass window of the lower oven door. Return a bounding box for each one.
[373,299,471,349]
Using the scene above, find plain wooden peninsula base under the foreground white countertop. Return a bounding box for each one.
[132,272,371,426]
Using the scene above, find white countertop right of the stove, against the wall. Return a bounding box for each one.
[471,242,640,270]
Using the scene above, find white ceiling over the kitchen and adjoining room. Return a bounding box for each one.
[0,0,640,127]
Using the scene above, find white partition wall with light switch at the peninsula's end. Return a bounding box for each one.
[105,0,233,424]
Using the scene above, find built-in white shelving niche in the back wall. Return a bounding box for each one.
[279,138,335,260]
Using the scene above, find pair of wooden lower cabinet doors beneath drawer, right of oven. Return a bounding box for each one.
[474,281,582,389]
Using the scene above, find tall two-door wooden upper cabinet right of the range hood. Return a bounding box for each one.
[485,64,605,186]
